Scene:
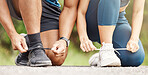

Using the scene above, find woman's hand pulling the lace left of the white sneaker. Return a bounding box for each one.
[80,39,97,52]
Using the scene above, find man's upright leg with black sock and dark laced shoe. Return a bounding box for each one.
[13,0,52,66]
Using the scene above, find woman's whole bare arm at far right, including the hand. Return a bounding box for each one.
[127,0,145,52]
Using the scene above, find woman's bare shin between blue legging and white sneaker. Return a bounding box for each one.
[98,26,115,43]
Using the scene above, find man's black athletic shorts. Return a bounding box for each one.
[7,0,61,32]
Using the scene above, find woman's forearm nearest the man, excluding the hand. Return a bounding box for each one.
[77,0,90,41]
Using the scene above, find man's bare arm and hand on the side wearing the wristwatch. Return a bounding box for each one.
[52,0,78,53]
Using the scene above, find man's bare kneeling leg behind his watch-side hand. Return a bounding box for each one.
[41,30,68,66]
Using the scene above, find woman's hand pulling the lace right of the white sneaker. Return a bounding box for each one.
[126,39,139,53]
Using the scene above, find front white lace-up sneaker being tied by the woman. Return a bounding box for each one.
[98,43,121,66]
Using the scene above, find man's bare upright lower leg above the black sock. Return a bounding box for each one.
[13,0,42,34]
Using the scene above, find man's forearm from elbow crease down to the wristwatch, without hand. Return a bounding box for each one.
[59,2,77,39]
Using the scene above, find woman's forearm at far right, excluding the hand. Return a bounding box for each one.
[131,0,144,40]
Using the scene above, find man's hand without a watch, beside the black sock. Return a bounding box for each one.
[10,33,28,53]
